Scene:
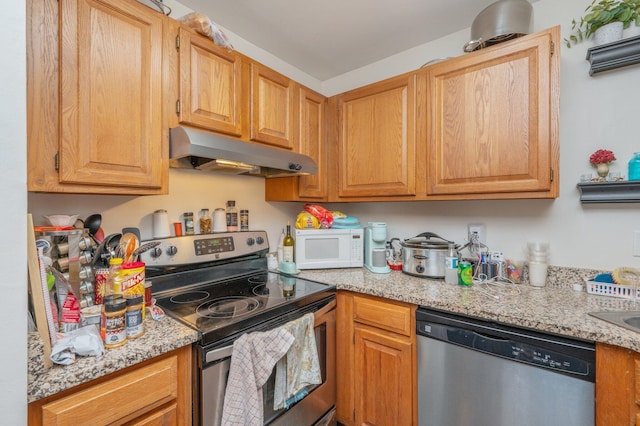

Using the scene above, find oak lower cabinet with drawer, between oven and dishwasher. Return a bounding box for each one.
[336,292,417,425]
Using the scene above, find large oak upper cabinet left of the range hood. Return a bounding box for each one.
[27,0,169,195]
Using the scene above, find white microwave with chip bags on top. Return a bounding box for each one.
[295,228,364,269]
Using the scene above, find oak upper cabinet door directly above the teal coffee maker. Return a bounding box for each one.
[338,74,416,198]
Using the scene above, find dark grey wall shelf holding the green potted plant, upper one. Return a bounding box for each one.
[587,36,640,76]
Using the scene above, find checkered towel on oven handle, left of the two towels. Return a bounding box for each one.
[222,327,294,426]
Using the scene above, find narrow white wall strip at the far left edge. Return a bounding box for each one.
[0,0,27,425]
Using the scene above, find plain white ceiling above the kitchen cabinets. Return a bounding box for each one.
[180,0,524,81]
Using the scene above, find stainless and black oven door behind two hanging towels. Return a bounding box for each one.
[201,299,336,426]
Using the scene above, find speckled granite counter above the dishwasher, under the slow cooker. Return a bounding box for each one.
[300,267,640,351]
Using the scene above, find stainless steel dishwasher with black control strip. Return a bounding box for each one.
[416,308,595,426]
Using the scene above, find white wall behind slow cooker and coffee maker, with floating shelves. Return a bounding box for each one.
[316,0,640,269]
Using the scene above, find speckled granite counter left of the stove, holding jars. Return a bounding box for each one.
[27,316,198,402]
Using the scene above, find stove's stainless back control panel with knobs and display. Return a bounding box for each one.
[140,231,269,267]
